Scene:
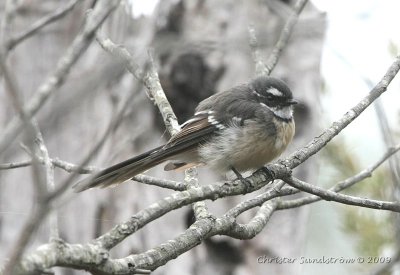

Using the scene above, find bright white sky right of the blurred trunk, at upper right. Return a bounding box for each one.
[313,0,400,164]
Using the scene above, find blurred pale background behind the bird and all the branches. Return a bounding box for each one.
[0,0,400,275]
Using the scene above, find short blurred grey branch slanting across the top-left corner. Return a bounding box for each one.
[5,0,82,51]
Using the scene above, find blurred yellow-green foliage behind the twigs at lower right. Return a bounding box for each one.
[323,139,395,256]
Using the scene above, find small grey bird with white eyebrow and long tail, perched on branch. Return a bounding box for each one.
[73,75,297,192]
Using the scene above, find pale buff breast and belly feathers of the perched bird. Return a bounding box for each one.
[199,118,294,172]
